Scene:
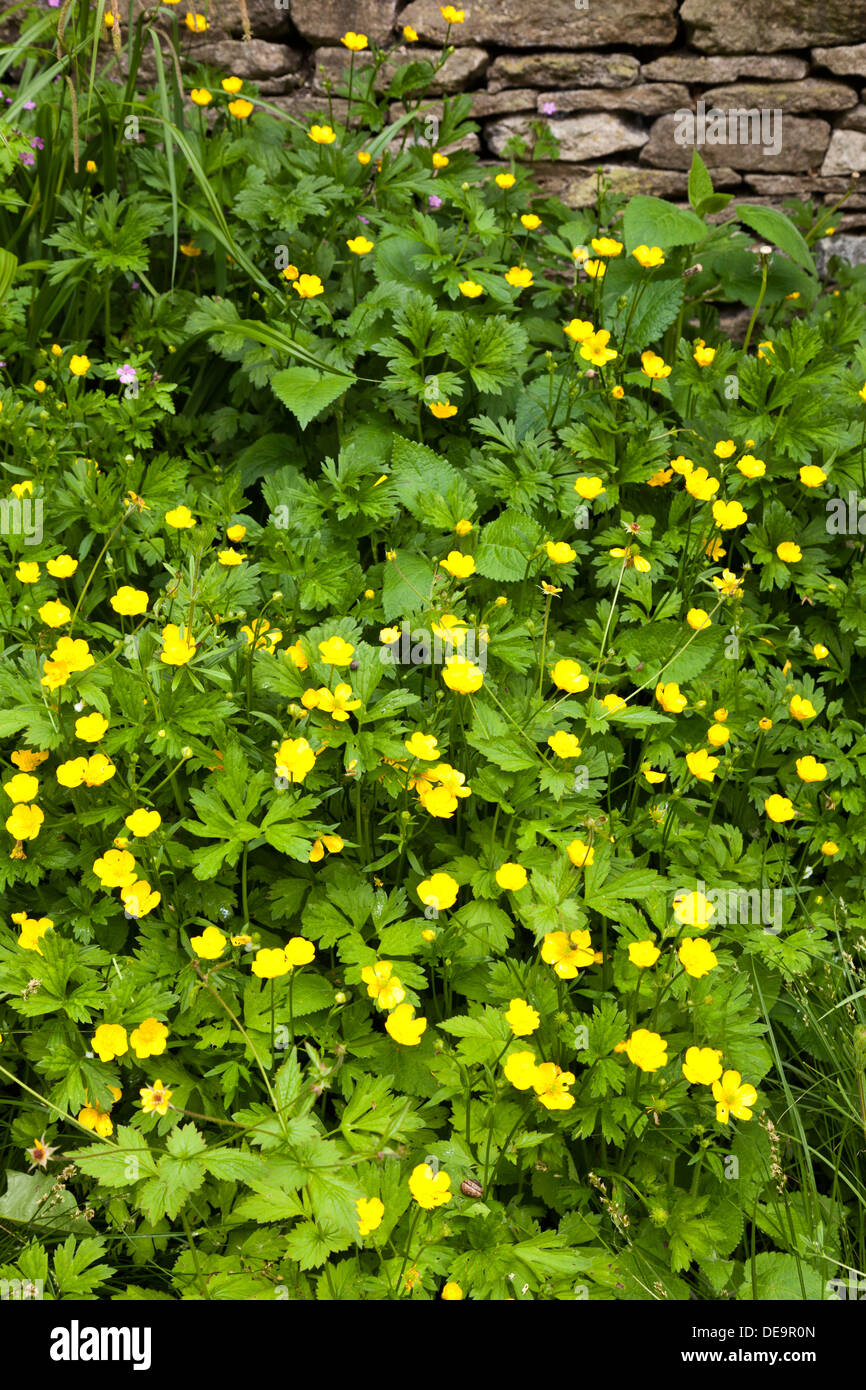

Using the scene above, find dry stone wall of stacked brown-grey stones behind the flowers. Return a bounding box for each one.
[123,0,866,232]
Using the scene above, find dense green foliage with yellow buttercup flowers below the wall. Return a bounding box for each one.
[0,0,866,1301]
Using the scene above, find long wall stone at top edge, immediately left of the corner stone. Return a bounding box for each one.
[400,0,677,49]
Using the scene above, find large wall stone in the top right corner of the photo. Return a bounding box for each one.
[680,0,866,53]
